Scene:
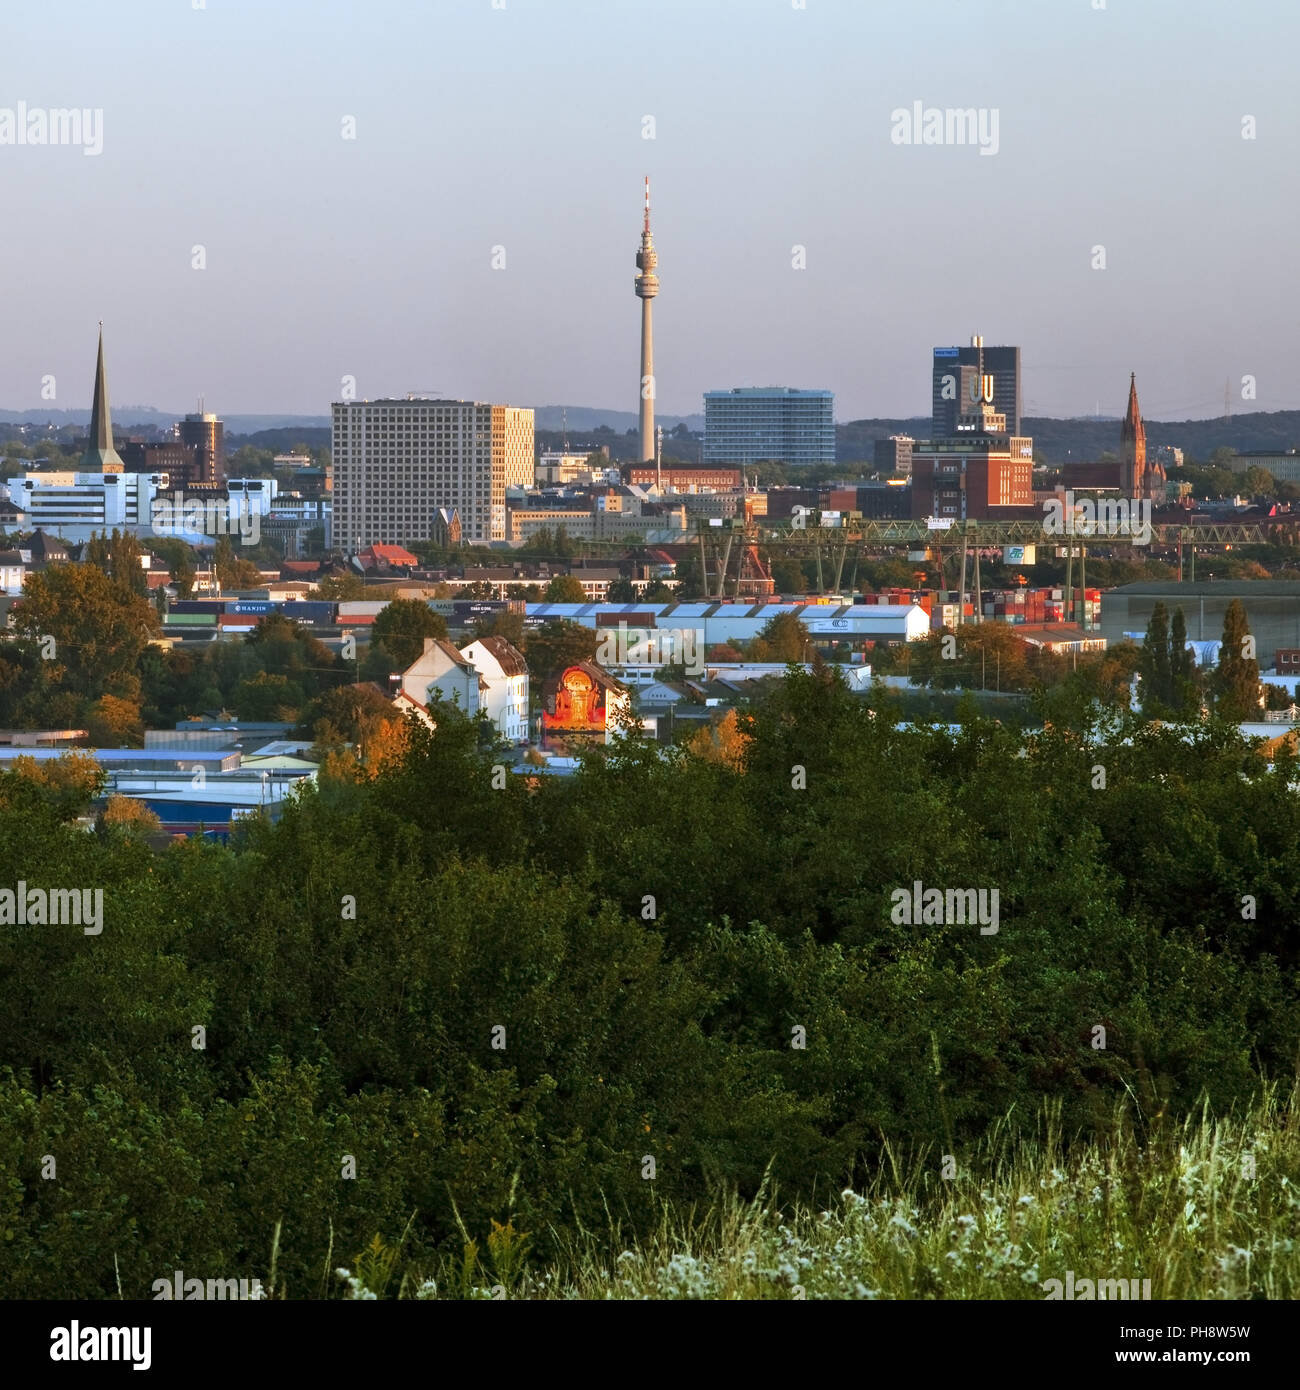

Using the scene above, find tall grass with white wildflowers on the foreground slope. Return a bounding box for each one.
[336,1090,1300,1300]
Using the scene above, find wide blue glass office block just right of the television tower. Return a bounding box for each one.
[704,386,836,467]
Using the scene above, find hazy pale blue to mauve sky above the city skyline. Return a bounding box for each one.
[0,0,1300,420]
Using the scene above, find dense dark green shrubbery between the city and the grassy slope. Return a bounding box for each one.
[0,674,1300,1297]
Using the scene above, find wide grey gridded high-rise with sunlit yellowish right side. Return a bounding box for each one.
[331,396,533,550]
